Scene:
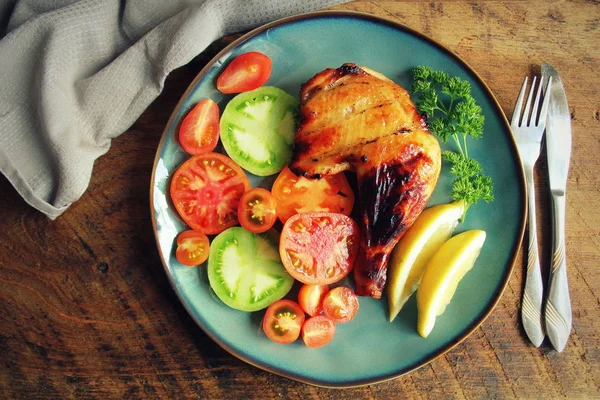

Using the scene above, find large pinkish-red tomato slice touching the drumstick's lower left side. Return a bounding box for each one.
[279,212,359,285]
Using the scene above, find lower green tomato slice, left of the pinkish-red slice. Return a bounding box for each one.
[208,227,294,312]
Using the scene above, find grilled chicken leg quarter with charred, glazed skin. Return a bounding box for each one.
[290,64,441,298]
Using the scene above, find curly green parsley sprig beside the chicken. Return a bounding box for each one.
[412,66,494,221]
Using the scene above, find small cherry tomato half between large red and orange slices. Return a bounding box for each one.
[238,188,277,233]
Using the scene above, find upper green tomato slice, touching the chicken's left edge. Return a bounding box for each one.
[220,86,298,176]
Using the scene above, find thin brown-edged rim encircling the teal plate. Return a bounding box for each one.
[150,10,527,389]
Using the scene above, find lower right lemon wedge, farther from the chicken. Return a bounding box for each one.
[417,230,486,337]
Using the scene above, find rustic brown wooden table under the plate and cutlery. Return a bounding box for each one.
[0,0,600,399]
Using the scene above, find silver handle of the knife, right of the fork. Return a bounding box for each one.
[545,194,571,352]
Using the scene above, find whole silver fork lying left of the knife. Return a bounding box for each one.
[511,76,552,347]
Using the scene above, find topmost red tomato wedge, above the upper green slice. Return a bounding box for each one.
[217,51,272,94]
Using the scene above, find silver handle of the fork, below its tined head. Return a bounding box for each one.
[521,168,544,347]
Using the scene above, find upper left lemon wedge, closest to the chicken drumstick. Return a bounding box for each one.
[387,201,465,322]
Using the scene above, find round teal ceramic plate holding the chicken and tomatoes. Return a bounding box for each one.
[150,11,525,387]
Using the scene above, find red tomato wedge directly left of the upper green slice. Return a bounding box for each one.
[179,99,219,154]
